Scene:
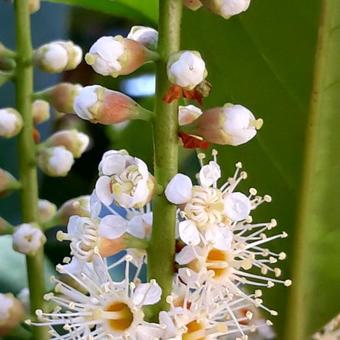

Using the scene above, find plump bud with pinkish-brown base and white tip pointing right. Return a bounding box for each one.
[197,104,263,146]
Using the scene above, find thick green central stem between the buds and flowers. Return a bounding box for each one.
[148,0,182,320]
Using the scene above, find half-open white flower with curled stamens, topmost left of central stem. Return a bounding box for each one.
[95,150,155,208]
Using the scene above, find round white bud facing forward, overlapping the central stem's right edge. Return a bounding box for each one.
[167,51,208,90]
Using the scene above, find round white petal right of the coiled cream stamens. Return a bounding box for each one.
[224,192,251,221]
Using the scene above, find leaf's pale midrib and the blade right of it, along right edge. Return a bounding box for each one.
[285,0,340,340]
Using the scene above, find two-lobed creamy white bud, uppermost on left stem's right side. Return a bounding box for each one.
[34,40,83,73]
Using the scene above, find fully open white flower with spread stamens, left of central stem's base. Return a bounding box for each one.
[29,256,162,340]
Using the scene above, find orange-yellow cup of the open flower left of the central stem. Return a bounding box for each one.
[103,301,133,332]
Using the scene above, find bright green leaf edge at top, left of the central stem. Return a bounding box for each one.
[45,0,158,24]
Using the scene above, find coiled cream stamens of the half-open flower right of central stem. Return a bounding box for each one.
[184,186,224,228]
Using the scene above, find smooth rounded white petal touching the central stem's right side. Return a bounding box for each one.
[165,174,192,204]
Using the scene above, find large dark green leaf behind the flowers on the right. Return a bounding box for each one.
[182,0,340,340]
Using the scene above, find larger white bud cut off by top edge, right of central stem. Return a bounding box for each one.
[201,0,250,19]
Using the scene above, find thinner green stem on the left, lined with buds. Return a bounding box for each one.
[15,0,48,340]
